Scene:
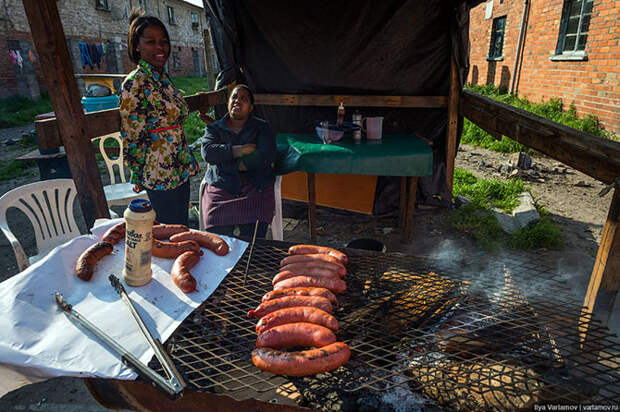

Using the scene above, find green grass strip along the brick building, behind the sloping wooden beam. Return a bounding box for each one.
[461,84,617,153]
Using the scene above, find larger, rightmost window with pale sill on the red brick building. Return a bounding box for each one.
[555,0,594,54]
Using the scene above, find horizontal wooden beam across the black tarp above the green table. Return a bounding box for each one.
[254,94,448,108]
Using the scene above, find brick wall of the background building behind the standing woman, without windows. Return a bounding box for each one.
[0,0,206,98]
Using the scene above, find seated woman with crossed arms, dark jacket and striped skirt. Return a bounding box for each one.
[200,84,276,238]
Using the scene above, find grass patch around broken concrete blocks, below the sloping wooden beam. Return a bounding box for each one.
[448,169,562,251]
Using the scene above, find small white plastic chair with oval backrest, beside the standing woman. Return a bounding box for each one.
[92,133,148,217]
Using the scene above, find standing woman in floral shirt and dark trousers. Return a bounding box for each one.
[119,9,198,225]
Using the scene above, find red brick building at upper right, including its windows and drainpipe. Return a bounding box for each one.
[468,0,620,134]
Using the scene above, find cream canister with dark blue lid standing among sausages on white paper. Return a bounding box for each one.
[123,199,155,286]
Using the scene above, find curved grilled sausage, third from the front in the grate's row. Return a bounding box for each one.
[256,306,338,336]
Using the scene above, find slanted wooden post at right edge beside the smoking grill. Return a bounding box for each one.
[582,187,620,332]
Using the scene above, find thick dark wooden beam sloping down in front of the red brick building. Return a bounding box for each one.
[460,90,620,184]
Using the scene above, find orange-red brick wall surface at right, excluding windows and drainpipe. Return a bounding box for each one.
[468,0,620,134]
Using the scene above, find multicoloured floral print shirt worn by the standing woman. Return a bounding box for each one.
[119,60,198,190]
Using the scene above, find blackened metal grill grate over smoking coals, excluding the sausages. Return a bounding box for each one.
[151,241,620,409]
